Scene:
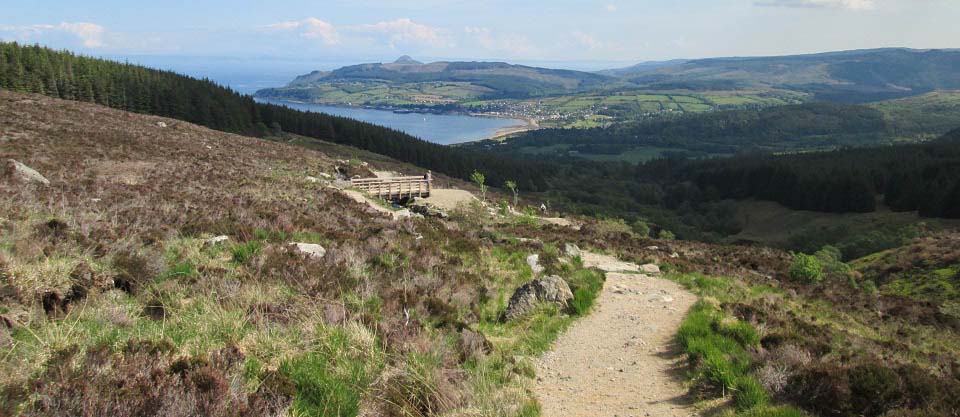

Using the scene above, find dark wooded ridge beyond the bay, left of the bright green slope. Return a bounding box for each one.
[472,103,888,154]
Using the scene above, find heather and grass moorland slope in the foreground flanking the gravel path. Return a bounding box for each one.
[7,90,960,417]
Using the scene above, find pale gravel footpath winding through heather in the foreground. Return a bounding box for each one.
[534,253,697,417]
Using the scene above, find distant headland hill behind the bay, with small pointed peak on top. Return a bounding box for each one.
[257,57,613,106]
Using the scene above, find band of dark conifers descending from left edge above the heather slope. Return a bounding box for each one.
[0,42,550,189]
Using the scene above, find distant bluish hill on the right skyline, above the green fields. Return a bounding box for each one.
[622,48,960,103]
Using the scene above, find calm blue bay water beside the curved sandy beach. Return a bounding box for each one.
[261,100,525,145]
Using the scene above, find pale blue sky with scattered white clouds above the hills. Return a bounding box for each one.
[0,0,960,69]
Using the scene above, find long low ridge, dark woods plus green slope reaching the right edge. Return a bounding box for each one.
[480,91,960,163]
